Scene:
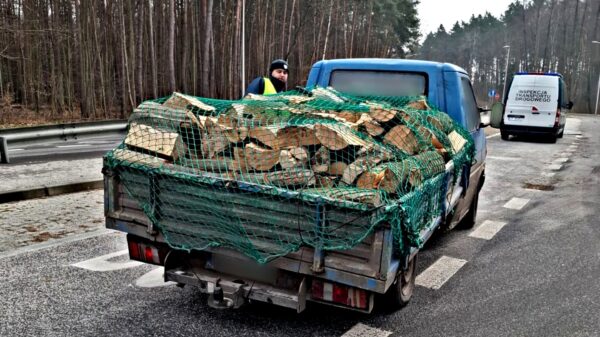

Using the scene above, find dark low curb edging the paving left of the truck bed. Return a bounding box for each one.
[0,180,104,204]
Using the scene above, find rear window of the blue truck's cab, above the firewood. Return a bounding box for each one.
[329,70,427,96]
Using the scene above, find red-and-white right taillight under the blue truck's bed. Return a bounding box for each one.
[311,280,369,309]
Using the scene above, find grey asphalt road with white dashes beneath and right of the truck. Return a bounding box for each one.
[0,116,600,337]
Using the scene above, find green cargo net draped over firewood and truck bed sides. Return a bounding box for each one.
[105,87,474,263]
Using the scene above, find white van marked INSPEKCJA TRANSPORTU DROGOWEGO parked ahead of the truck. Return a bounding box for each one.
[500,72,573,142]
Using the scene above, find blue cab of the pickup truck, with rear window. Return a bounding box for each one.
[307,58,487,228]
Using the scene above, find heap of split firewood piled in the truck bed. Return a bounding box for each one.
[112,88,472,207]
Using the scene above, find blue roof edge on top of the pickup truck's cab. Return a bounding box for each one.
[313,58,467,74]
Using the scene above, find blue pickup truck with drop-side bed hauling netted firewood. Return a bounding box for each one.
[104,59,486,313]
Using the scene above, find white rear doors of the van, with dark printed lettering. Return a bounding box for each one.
[504,75,559,128]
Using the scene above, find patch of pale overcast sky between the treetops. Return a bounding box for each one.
[417,0,514,40]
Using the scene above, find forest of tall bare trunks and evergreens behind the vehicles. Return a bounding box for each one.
[0,0,600,125]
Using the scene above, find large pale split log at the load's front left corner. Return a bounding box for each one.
[125,123,187,161]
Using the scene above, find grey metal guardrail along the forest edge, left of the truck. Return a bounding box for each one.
[0,120,127,164]
